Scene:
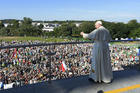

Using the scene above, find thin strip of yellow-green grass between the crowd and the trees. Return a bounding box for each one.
[0,36,140,46]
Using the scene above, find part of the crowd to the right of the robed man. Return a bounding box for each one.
[110,44,139,71]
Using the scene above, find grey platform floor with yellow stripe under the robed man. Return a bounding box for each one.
[0,69,140,93]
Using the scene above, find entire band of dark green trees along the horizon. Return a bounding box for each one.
[0,17,140,39]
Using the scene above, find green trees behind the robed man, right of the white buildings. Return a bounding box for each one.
[48,20,140,39]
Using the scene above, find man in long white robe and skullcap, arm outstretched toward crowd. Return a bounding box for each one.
[80,21,113,83]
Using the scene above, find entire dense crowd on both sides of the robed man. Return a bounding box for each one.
[0,41,139,89]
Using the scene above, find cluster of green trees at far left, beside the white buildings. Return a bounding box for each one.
[0,17,43,36]
